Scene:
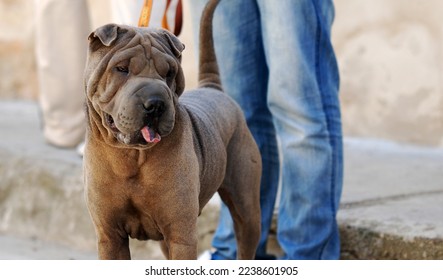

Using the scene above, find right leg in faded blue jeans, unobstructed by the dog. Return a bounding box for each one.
[258,0,343,259]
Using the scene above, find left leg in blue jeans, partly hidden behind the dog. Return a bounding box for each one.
[192,0,279,259]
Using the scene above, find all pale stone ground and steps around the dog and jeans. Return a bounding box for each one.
[0,101,443,259]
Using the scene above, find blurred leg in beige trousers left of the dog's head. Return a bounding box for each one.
[35,0,90,147]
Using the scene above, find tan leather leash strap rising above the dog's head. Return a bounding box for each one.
[138,0,183,36]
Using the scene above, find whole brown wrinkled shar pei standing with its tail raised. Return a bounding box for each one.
[84,1,261,259]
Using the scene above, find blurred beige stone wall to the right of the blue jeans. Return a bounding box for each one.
[333,0,443,147]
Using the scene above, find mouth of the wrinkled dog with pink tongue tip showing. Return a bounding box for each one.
[105,113,161,145]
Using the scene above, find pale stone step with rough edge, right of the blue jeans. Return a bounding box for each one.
[338,139,443,259]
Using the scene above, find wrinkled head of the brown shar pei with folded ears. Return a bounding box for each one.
[85,24,184,148]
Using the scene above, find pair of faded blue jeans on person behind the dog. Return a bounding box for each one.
[190,0,343,259]
